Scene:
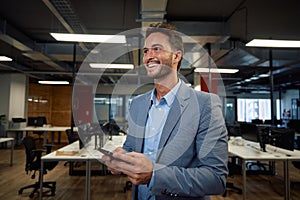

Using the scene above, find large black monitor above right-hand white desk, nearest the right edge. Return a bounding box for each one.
[270,128,295,151]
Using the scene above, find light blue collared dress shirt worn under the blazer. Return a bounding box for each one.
[138,79,181,200]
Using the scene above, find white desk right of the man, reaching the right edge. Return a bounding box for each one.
[228,141,300,200]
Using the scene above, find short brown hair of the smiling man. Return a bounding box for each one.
[146,23,184,71]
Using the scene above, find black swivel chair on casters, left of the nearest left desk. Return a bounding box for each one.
[19,136,58,198]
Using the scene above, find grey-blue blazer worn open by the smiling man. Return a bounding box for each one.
[124,81,228,200]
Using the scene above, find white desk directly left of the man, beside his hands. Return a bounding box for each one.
[39,136,126,200]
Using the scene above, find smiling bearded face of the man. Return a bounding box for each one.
[143,32,177,79]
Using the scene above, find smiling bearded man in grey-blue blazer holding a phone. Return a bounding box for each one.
[102,23,228,200]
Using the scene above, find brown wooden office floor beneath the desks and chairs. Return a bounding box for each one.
[0,146,300,200]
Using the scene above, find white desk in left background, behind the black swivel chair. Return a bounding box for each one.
[6,126,71,144]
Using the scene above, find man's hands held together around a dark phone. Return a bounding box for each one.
[102,147,153,185]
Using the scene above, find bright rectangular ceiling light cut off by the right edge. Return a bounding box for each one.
[246,39,300,48]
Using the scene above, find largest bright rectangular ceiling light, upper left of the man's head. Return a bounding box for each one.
[50,33,126,44]
